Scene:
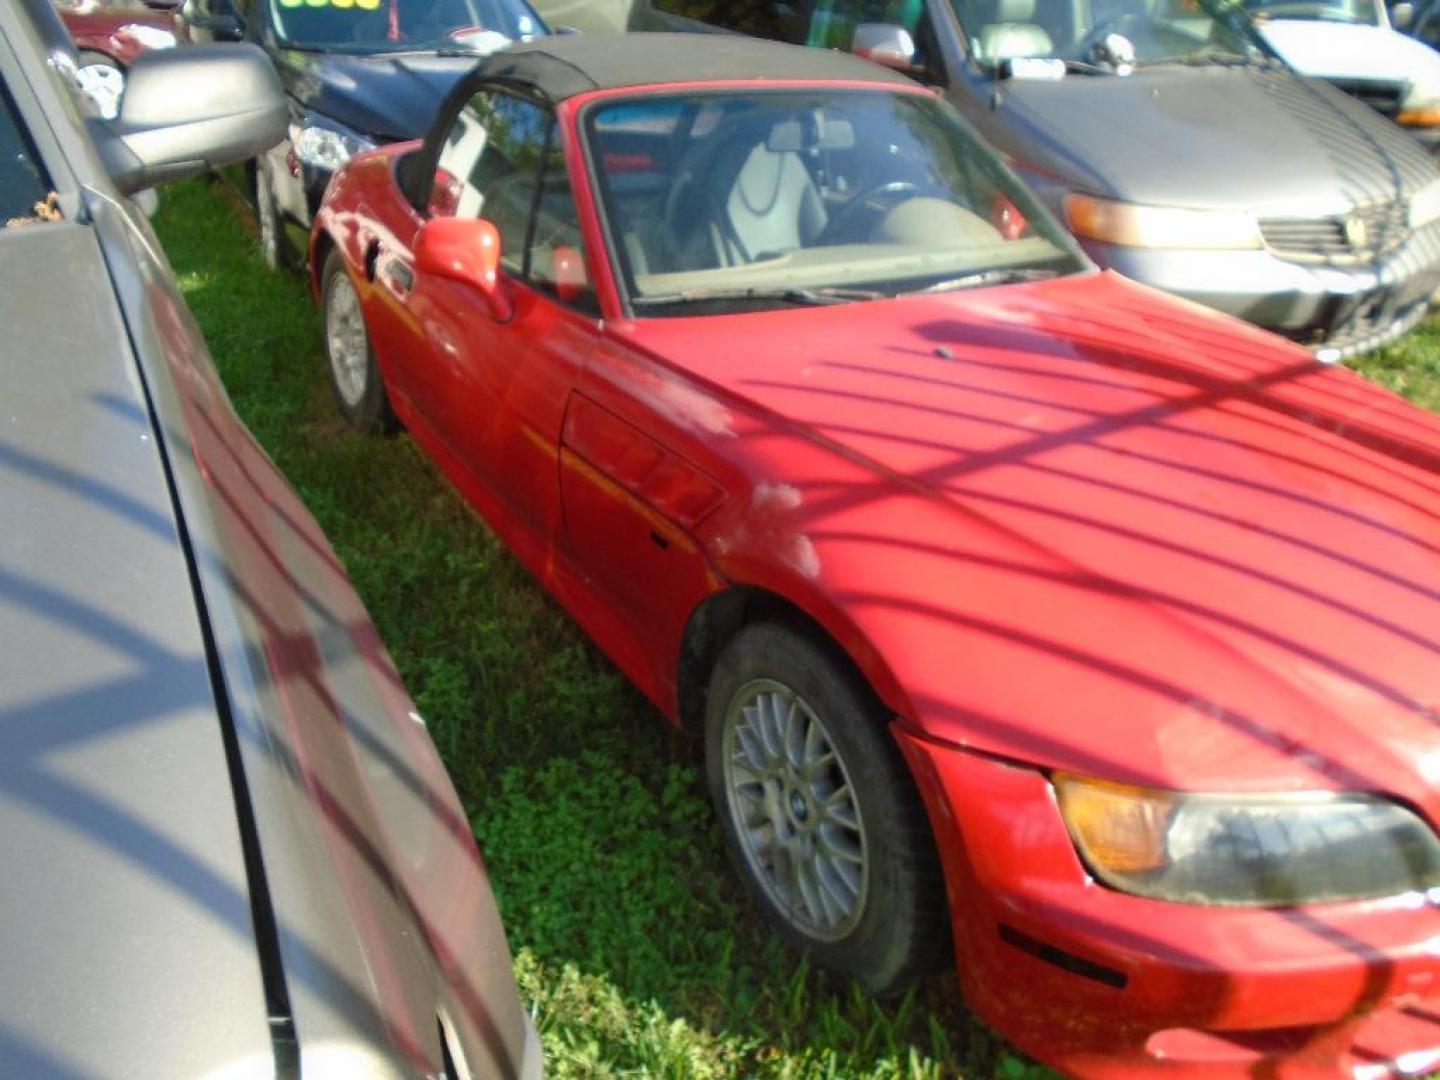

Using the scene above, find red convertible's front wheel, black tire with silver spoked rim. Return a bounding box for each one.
[706,622,950,996]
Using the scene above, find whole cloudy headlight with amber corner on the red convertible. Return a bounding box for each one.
[1053,773,1440,907]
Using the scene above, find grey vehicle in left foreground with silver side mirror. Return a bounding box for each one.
[0,0,540,1079]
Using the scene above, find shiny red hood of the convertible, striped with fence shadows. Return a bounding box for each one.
[618,274,1440,816]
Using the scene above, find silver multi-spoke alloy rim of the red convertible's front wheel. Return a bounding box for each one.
[721,678,870,942]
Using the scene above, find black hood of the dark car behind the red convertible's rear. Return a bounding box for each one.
[275,49,482,143]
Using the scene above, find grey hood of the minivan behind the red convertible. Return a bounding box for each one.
[986,66,1436,217]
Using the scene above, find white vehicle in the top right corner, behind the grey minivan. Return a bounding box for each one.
[1246,0,1440,151]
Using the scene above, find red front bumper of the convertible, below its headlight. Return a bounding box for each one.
[894,727,1440,1080]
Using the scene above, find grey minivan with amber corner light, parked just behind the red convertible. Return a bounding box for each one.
[632,0,1440,359]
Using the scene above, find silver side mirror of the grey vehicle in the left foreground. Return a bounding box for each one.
[95,45,289,194]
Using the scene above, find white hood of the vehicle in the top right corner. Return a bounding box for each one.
[1259,19,1440,84]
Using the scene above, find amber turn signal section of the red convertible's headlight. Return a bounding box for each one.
[1054,773,1179,874]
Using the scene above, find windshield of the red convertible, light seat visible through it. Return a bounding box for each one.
[585,91,1087,314]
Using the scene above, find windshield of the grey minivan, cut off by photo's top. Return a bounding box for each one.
[952,0,1270,70]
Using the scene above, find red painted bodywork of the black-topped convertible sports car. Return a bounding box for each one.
[315,80,1440,1077]
